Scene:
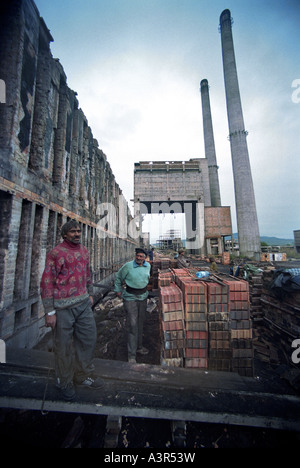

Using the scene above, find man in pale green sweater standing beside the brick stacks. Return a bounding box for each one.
[115,248,151,363]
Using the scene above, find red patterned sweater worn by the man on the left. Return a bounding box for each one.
[41,240,93,313]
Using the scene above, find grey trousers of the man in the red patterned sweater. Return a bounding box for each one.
[54,299,97,387]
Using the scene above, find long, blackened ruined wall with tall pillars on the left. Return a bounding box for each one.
[0,0,135,347]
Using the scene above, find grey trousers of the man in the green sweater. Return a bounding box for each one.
[124,299,147,359]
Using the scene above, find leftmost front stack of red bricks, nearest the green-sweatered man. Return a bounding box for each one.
[159,283,185,367]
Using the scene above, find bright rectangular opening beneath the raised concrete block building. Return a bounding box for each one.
[142,213,186,250]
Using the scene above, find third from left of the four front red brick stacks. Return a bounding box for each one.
[207,282,232,371]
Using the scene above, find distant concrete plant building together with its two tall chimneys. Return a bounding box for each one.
[134,10,260,260]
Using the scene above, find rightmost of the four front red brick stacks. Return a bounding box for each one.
[223,278,254,377]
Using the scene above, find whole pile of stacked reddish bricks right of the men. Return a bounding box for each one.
[159,268,253,376]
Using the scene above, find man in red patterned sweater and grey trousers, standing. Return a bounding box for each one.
[41,220,103,400]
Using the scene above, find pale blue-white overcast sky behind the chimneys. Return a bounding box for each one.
[35,0,300,238]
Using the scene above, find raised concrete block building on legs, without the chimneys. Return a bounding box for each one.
[134,158,232,256]
